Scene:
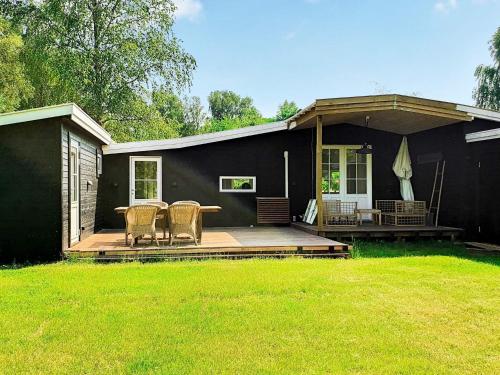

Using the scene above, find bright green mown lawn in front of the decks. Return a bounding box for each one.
[0,243,500,374]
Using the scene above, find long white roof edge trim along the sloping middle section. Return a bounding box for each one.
[103,122,286,155]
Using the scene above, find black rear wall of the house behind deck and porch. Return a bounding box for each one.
[101,125,401,228]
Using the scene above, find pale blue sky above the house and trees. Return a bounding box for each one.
[175,0,500,116]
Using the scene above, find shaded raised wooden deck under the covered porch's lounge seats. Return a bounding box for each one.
[292,223,463,241]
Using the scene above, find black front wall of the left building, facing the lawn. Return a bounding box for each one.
[0,119,61,262]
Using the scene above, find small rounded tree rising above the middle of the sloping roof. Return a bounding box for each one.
[208,90,260,120]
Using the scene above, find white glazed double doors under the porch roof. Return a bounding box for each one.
[322,145,372,208]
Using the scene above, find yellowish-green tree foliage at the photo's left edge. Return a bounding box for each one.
[0,18,33,112]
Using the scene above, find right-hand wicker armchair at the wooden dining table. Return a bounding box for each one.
[168,201,200,245]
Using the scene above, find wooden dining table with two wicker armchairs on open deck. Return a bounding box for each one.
[115,201,221,247]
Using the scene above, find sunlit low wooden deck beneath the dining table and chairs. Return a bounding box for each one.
[65,227,349,259]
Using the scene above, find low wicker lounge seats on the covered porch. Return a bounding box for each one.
[324,200,426,226]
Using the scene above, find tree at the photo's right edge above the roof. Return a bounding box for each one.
[473,27,500,111]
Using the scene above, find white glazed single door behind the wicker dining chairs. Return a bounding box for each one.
[130,156,161,206]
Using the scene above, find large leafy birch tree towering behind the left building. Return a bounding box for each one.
[2,0,196,126]
